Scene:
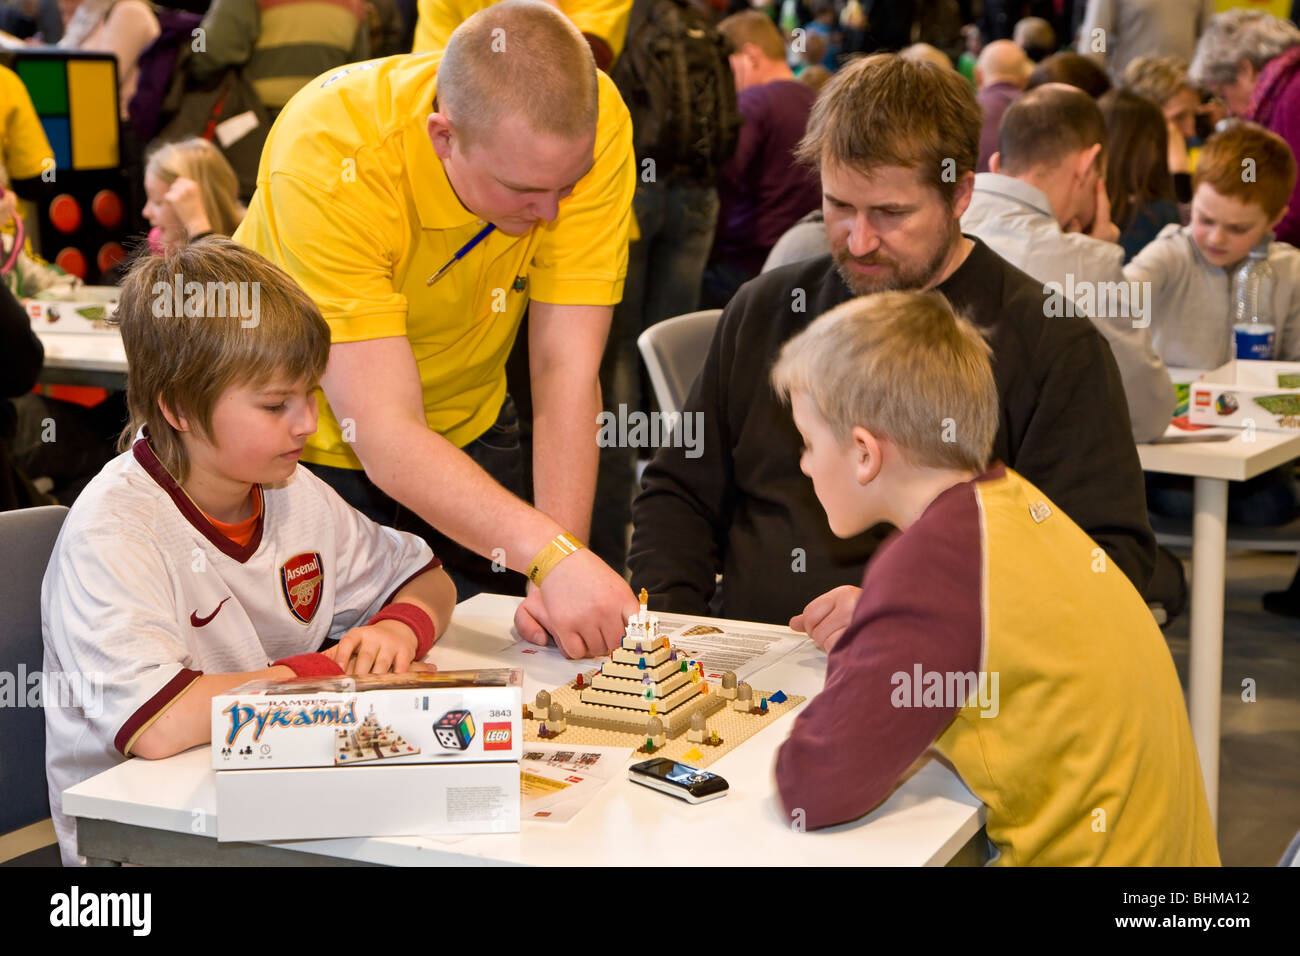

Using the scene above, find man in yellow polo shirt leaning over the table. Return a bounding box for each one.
[234,0,637,657]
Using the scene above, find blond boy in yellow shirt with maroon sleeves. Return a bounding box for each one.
[772,293,1219,865]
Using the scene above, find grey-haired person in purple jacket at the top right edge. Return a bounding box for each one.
[1190,9,1300,246]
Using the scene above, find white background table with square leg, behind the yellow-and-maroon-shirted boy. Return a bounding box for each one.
[1138,425,1300,822]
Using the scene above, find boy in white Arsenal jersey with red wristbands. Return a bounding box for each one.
[42,238,456,864]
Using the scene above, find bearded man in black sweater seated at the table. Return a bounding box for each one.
[628,55,1156,644]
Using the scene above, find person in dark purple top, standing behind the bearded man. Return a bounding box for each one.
[699,10,822,308]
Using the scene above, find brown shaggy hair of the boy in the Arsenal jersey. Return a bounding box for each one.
[114,237,329,483]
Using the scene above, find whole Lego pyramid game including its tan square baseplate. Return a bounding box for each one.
[524,588,803,767]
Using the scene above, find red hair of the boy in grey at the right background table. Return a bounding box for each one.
[1192,122,1296,221]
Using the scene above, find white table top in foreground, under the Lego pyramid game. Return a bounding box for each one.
[64,594,984,866]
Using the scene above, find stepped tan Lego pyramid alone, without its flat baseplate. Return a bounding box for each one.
[567,588,725,737]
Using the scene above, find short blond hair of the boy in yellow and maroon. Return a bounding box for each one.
[772,291,998,471]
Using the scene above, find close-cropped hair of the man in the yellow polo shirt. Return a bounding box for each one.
[437,0,599,146]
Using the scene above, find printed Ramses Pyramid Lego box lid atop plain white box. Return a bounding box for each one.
[212,667,523,770]
